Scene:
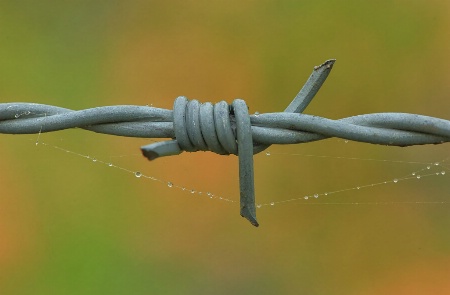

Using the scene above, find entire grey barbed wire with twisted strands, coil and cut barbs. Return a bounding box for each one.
[0,59,450,226]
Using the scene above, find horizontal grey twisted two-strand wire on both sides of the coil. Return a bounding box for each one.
[0,103,450,147]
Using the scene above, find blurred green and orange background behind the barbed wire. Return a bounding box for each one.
[0,0,450,294]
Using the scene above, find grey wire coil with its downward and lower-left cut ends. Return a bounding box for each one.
[141,96,258,226]
